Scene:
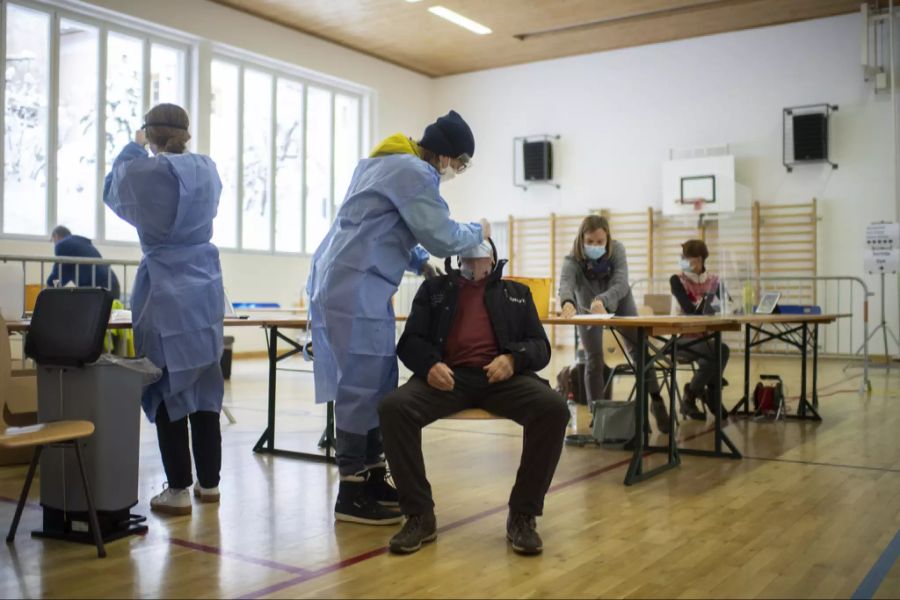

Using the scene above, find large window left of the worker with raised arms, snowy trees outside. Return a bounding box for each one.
[0,2,190,241]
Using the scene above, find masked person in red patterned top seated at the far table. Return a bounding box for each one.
[669,240,729,421]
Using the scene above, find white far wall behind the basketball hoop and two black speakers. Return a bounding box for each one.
[433,15,897,351]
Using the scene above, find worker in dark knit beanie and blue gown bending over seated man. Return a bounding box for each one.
[307,111,490,525]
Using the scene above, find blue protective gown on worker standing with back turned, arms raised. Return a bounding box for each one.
[103,142,225,421]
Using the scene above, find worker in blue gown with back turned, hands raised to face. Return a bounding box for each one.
[103,104,225,515]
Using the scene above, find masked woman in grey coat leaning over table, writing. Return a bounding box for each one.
[559,215,669,433]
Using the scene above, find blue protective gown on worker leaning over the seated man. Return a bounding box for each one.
[307,149,482,434]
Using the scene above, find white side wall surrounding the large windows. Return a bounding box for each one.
[0,0,433,352]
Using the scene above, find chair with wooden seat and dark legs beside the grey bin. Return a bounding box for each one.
[0,421,106,558]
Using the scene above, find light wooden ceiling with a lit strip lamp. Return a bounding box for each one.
[214,0,861,77]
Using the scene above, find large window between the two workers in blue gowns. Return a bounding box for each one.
[209,57,363,253]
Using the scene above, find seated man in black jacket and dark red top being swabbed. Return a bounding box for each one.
[379,243,569,554]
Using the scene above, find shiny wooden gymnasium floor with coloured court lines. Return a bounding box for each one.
[0,352,900,598]
